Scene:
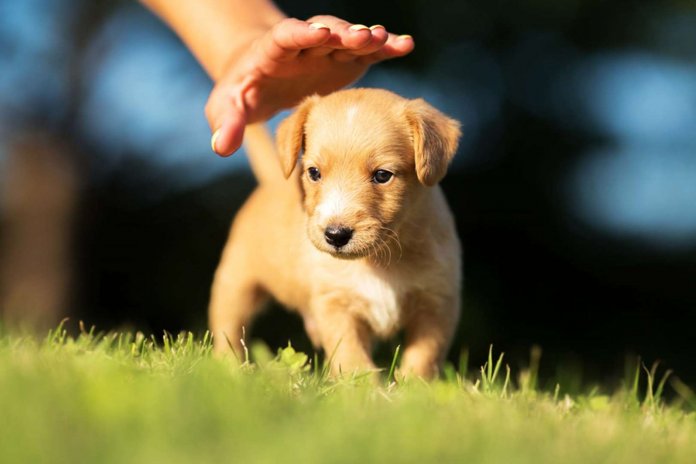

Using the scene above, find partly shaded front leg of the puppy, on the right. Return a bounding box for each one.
[401,298,459,379]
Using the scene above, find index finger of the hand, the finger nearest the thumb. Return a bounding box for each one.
[262,18,332,61]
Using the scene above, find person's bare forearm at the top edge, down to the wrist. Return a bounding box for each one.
[141,0,285,81]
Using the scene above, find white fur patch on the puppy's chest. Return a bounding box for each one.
[353,273,399,334]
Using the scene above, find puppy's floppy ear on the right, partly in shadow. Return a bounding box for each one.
[406,98,461,186]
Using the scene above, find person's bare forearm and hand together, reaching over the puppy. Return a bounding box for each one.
[142,0,414,156]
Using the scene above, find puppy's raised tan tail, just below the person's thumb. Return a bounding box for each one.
[244,123,285,184]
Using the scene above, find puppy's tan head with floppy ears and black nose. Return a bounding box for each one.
[277,89,460,258]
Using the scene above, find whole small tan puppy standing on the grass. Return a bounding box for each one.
[209,89,460,378]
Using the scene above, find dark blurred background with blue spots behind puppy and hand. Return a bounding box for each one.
[0,0,696,388]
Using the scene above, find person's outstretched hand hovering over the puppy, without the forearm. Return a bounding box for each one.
[205,16,414,156]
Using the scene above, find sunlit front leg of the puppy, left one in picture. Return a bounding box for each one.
[312,297,375,375]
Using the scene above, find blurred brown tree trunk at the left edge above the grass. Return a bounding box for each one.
[0,136,78,331]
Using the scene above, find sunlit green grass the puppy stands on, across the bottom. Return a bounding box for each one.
[0,322,696,464]
